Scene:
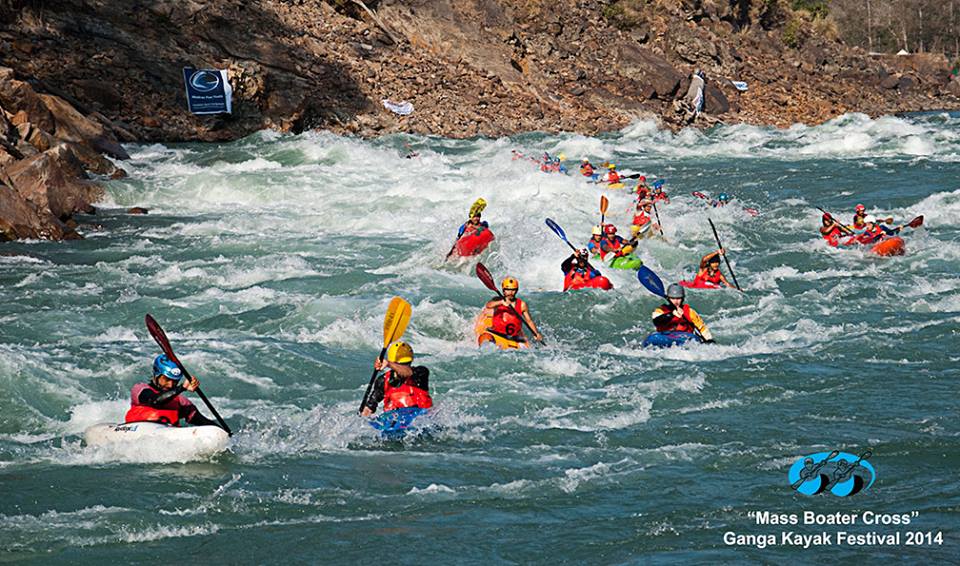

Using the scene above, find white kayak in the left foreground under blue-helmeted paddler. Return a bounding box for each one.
[83,421,230,456]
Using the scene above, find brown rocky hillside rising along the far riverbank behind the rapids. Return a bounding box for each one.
[0,0,960,145]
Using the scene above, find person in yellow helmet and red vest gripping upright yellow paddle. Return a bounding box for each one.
[360,342,433,417]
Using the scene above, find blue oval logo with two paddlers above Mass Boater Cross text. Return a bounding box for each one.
[787,448,877,497]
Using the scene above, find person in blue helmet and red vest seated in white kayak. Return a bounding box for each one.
[124,354,217,426]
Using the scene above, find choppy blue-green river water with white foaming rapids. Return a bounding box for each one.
[0,114,960,564]
